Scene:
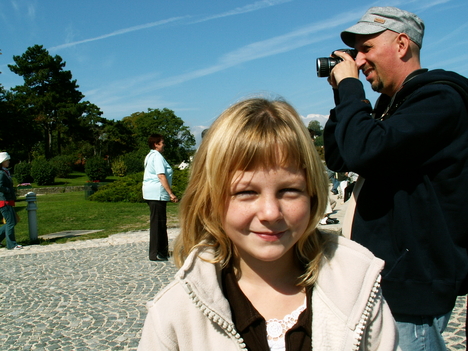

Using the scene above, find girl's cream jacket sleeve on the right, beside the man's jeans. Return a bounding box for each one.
[361,288,401,351]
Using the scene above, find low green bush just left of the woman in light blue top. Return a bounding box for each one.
[89,173,144,202]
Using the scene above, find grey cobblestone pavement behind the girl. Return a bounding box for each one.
[0,227,466,351]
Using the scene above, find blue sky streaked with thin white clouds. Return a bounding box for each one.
[0,0,468,144]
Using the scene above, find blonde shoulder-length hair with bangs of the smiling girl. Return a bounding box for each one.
[174,98,328,286]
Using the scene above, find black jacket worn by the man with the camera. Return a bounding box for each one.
[324,70,468,316]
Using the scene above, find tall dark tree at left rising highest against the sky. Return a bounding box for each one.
[8,45,84,158]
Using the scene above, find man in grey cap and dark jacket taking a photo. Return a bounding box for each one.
[319,7,468,351]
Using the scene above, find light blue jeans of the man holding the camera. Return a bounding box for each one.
[393,311,452,351]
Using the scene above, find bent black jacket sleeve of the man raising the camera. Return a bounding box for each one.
[324,78,466,178]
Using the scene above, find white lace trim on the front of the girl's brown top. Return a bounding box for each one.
[266,299,307,351]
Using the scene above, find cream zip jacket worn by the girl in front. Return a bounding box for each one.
[138,234,398,351]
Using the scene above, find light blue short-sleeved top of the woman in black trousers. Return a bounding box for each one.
[143,150,173,201]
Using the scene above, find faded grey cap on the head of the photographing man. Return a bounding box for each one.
[341,6,424,48]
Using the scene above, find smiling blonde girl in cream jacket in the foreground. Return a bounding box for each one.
[139,98,396,351]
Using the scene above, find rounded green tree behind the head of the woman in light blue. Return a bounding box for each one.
[122,108,195,164]
